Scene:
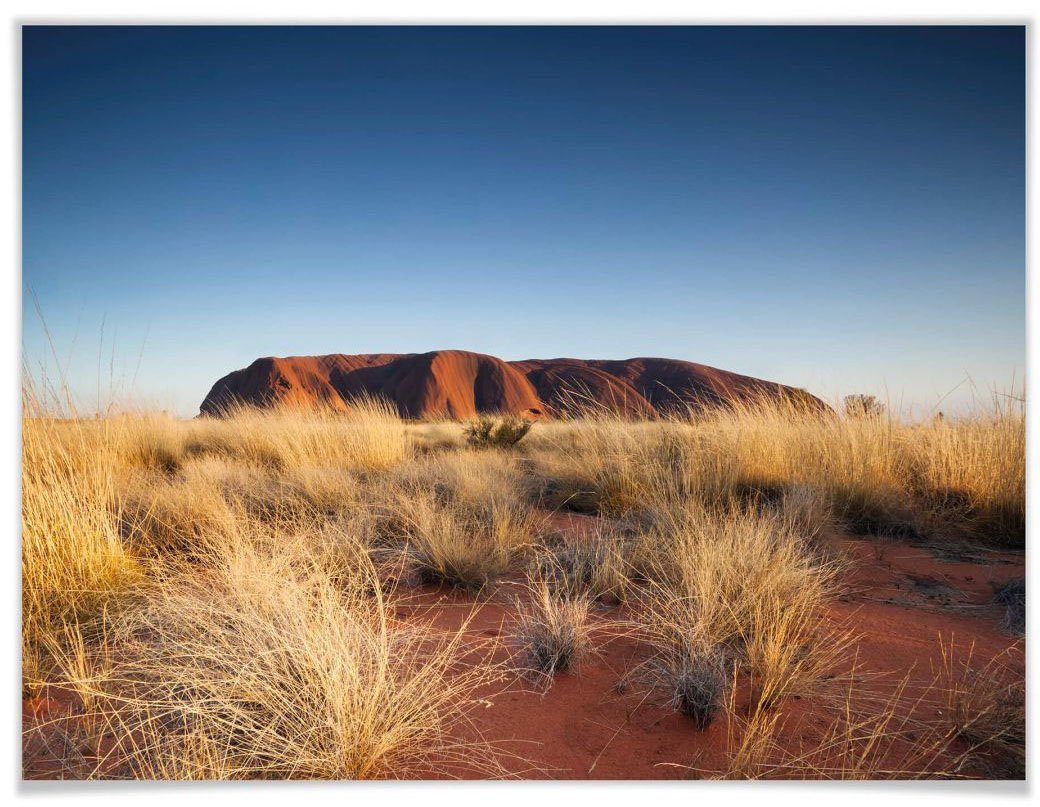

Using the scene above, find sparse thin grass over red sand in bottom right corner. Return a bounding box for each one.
[708,636,1025,780]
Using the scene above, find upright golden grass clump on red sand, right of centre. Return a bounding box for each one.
[630,503,851,727]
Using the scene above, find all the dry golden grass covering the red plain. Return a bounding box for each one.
[22,386,1024,779]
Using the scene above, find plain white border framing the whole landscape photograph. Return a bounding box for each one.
[0,0,1040,807]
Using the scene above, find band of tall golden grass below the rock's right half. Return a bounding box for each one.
[523,398,1025,547]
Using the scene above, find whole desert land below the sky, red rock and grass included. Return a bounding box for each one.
[22,352,1025,779]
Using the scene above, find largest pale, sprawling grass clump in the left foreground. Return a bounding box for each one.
[33,526,499,779]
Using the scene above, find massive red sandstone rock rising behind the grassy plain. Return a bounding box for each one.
[200,350,827,418]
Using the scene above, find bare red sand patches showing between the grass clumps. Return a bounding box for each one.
[23,515,1024,779]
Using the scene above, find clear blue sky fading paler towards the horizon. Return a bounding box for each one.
[23,27,1025,415]
